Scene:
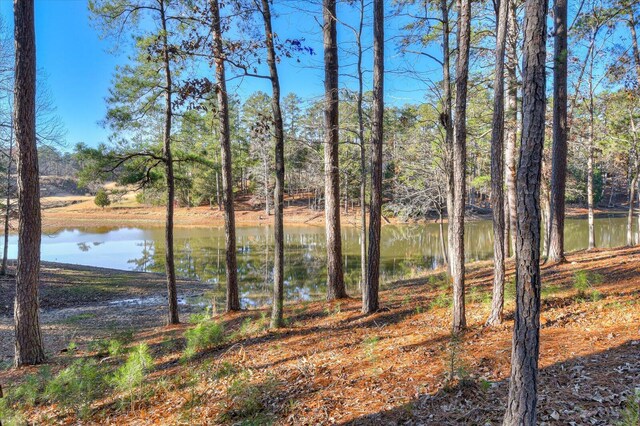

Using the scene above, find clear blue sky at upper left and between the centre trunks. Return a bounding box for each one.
[0,0,439,148]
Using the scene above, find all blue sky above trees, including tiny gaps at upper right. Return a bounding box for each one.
[0,0,625,149]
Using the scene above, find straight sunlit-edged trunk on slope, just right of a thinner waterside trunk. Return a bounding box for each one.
[449,0,471,332]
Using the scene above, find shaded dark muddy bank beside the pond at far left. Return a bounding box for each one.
[0,262,208,365]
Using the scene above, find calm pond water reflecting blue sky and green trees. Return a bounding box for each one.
[1,217,626,307]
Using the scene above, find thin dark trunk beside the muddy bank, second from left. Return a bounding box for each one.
[160,0,180,324]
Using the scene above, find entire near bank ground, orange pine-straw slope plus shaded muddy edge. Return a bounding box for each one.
[0,248,640,425]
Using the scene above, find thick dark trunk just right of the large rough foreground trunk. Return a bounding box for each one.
[548,0,569,262]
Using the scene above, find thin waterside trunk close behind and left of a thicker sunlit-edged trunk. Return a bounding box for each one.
[440,0,453,274]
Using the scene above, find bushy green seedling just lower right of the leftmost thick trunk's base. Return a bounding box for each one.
[45,359,106,419]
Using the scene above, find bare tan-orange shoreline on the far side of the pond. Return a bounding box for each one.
[42,194,626,227]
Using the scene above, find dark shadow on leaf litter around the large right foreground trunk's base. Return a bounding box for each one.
[340,341,640,426]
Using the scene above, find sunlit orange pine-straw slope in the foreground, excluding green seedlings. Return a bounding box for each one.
[0,248,640,425]
